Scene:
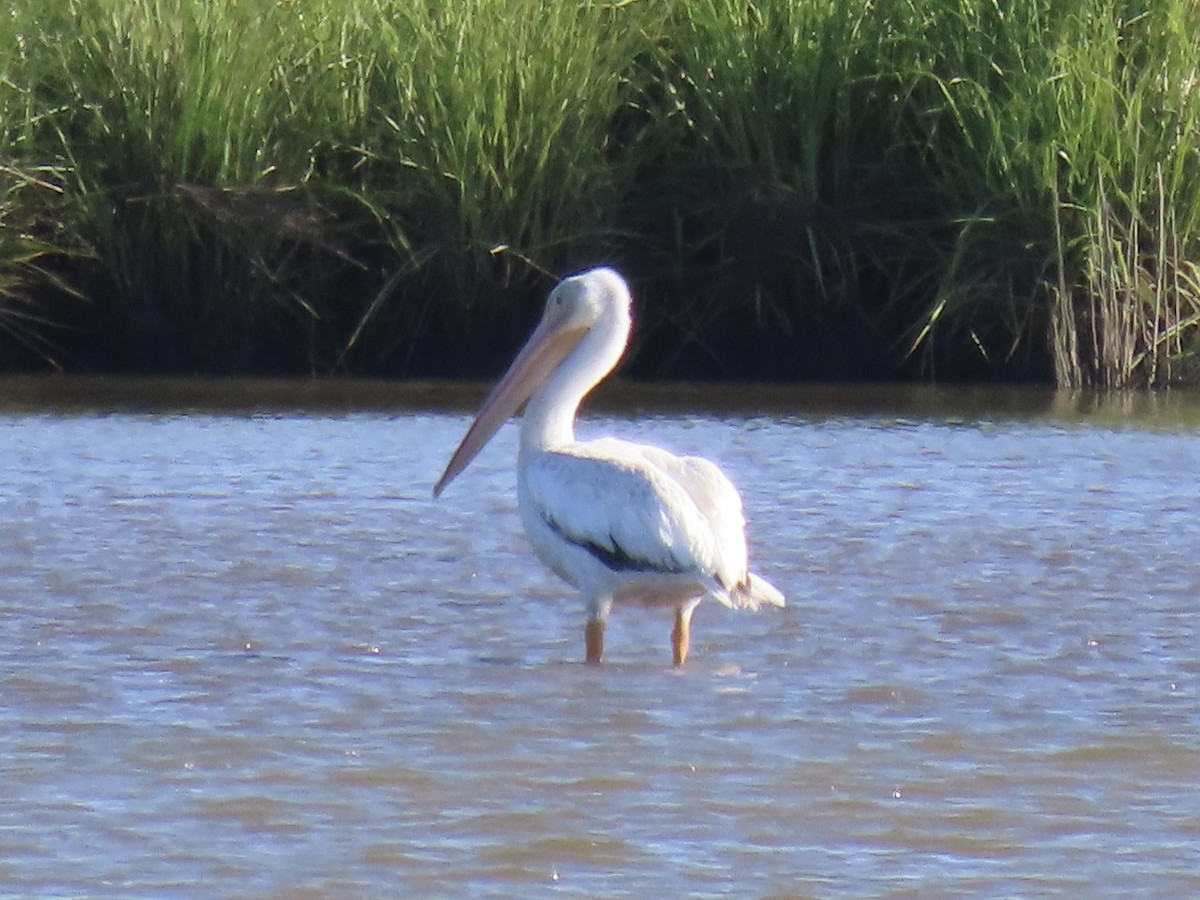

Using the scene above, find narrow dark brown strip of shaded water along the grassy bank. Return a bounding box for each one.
[0,374,1200,434]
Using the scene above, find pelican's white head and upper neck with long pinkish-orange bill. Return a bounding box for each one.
[433,268,632,497]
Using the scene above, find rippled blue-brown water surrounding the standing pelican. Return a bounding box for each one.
[0,382,1200,898]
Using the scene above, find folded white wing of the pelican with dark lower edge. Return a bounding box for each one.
[524,439,746,602]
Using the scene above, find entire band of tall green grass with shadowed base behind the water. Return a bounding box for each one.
[0,0,1200,389]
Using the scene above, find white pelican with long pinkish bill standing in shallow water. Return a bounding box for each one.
[433,269,784,665]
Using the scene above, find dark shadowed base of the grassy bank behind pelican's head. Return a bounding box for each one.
[14,256,1054,384]
